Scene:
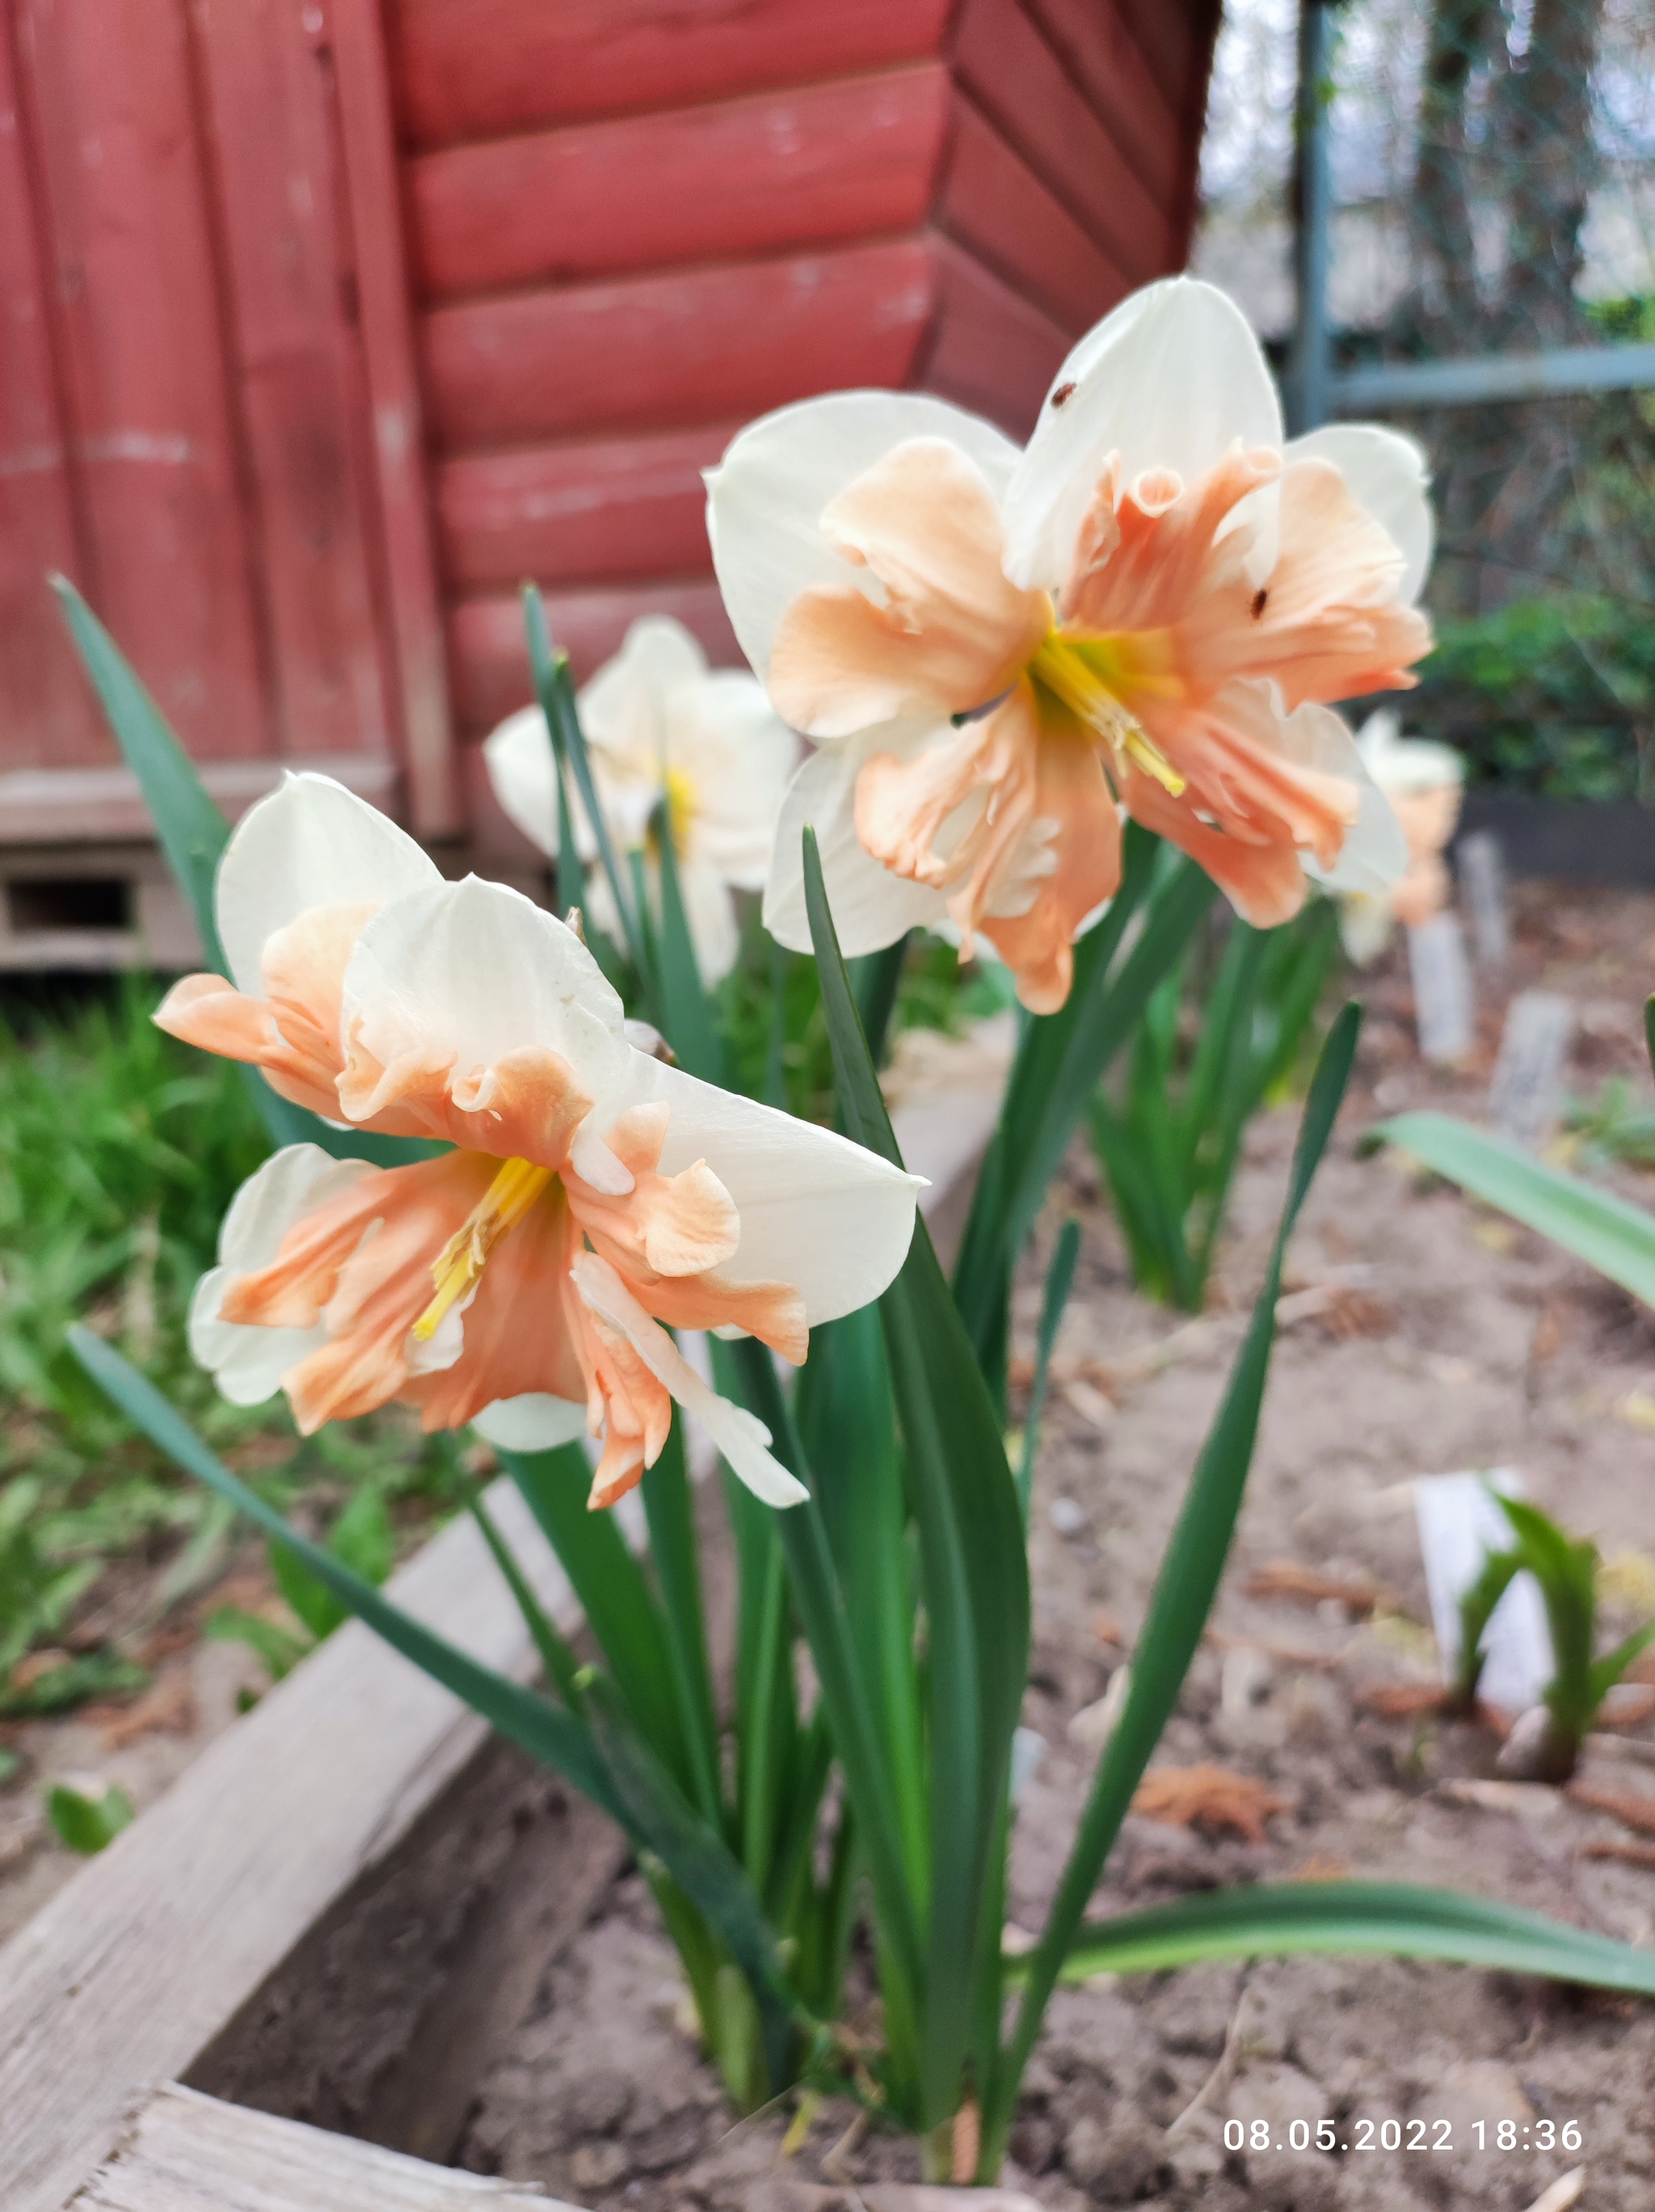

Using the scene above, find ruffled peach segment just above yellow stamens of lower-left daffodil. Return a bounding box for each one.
[339,1038,593,1168]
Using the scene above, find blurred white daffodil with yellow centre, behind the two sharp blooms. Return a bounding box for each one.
[482,615,798,984]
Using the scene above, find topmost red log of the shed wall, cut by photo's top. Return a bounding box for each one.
[392,0,955,148]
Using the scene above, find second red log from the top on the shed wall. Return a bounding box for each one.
[407,62,950,301]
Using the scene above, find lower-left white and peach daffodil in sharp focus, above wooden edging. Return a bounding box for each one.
[155,777,918,1506]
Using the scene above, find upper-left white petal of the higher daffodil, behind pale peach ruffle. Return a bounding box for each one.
[705,391,1017,677]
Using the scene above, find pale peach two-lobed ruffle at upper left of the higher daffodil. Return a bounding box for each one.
[768,438,1051,736]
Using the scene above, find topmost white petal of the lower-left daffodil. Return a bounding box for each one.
[215,774,443,997]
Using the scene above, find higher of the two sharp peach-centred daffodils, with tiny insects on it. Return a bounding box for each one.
[708,276,1431,1011]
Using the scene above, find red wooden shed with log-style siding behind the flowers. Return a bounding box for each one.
[0,0,1219,964]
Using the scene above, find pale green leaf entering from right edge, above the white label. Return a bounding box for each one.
[1367,1113,1655,1305]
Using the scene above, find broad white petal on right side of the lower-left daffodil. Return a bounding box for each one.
[588,1053,924,1327]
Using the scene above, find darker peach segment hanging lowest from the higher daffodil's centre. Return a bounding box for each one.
[983,717,1119,1013]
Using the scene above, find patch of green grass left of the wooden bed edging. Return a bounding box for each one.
[0,980,449,1717]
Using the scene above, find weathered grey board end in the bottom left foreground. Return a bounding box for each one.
[75,2082,560,2212]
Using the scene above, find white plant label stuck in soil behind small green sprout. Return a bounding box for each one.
[1414,1467,1556,1714]
